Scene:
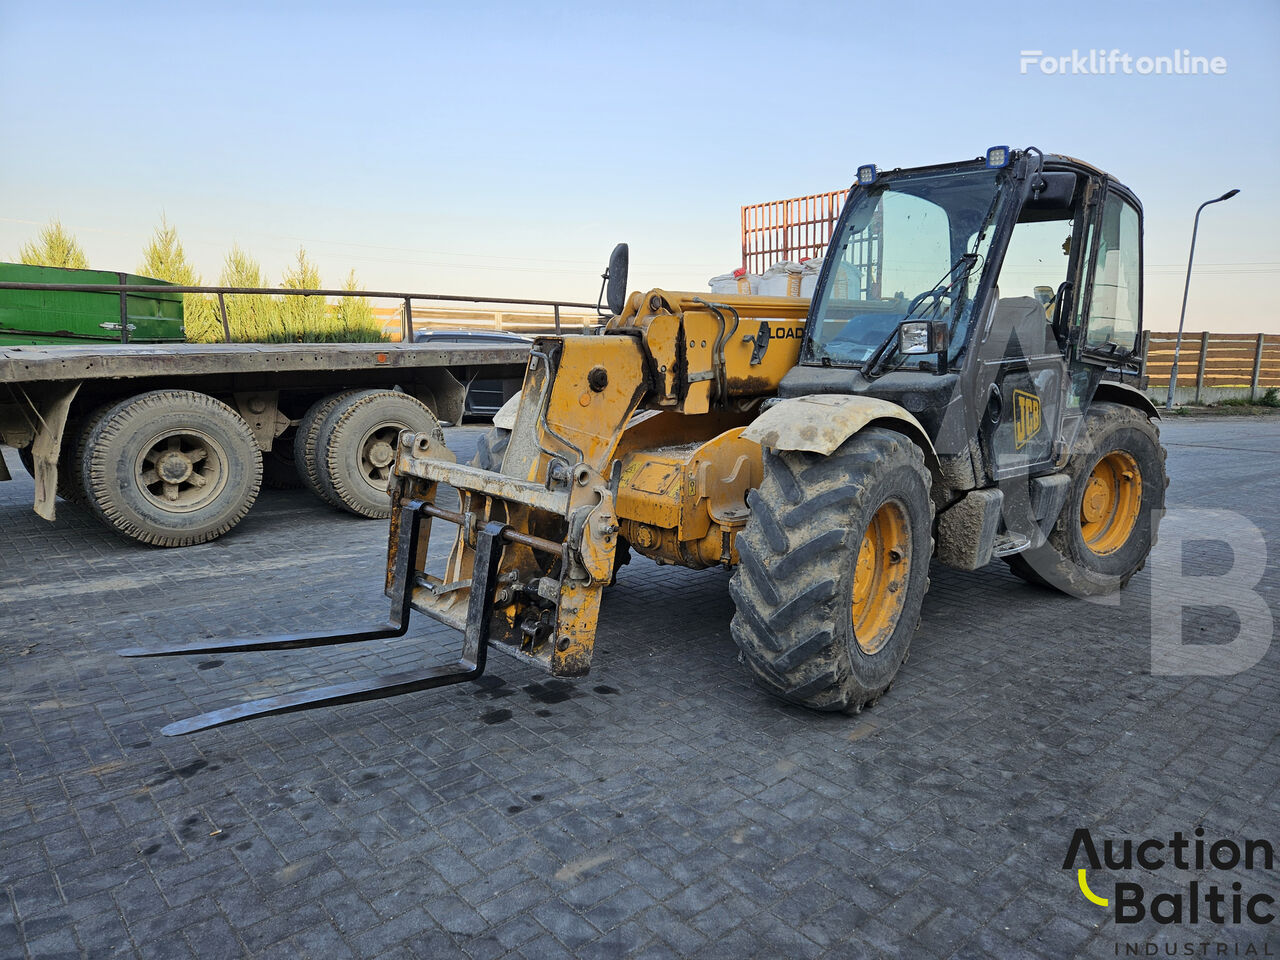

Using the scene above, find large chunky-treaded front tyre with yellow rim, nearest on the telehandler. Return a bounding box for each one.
[730,428,933,713]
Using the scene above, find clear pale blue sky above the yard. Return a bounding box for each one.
[0,0,1280,333]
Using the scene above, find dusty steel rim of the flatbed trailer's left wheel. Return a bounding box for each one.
[133,429,228,513]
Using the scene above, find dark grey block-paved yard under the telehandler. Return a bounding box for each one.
[0,420,1280,960]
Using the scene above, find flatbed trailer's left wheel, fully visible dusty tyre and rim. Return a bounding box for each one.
[83,390,262,547]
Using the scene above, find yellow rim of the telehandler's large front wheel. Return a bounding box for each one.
[852,500,911,654]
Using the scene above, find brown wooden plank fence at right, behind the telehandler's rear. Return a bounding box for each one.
[1143,330,1280,403]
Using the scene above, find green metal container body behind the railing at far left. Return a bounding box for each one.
[0,264,184,346]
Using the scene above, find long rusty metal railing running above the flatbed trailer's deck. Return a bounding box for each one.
[0,280,598,343]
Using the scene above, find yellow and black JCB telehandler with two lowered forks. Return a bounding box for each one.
[123,147,1167,733]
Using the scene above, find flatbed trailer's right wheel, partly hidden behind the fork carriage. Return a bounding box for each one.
[316,390,444,520]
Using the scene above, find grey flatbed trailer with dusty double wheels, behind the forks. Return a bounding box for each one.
[0,342,529,547]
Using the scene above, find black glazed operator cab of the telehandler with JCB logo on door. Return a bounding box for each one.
[782,147,1142,483]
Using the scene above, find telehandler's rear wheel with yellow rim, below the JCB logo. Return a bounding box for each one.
[1005,403,1169,596]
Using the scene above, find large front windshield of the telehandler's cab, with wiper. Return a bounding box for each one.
[805,169,1000,366]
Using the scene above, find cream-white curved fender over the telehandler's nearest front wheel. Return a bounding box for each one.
[742,393,938,474]
